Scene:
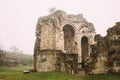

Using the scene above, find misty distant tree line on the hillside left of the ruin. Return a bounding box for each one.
[0,47,33,67]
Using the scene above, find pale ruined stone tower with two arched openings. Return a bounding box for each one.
[34,10,96,71]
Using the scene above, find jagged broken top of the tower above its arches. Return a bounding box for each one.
[38,10,95,31]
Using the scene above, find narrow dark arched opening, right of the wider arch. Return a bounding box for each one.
[81,36,89,68]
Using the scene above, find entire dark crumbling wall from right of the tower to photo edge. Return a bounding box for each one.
[91,22,120,74]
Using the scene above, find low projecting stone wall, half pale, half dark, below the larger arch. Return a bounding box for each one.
[36,50,78,74]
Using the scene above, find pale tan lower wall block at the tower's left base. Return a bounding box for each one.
[36,50,61,72]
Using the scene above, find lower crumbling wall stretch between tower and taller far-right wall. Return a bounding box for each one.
[86,34,108,74]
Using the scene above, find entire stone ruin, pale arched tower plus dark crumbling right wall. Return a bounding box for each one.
[34,10,120,74]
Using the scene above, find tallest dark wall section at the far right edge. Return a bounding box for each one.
[106,22,120,72]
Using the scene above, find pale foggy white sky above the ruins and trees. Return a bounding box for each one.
[0,0,120,54]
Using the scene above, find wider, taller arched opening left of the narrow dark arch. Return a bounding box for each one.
[63,24,75,53]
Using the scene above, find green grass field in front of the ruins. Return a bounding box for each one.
[0,67,120,80]
